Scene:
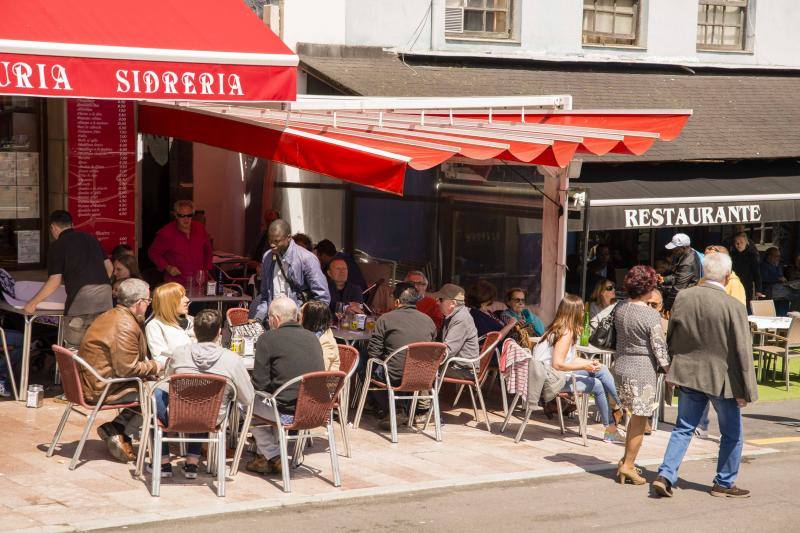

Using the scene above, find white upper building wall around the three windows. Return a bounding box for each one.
[285,0,800,68]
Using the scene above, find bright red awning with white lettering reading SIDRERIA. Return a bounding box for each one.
[0,0,298,102]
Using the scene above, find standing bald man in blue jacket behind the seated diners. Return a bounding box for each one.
[255,218,331,322]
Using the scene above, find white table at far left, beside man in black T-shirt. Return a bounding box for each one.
[0,281,67,401]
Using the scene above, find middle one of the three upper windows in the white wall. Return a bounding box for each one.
[583,0,640,45]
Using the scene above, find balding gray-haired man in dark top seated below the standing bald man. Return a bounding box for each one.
[247,296,325,474]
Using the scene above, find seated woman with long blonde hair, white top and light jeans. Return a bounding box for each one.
[533,294,624,442]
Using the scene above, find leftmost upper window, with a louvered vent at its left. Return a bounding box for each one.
[445,0,513,39]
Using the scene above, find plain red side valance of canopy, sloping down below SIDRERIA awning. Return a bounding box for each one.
[138,104,408,195]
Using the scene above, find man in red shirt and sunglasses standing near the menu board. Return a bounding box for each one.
[147,200,213,286]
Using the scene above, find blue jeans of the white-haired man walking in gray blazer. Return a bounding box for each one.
[658,387,744,488]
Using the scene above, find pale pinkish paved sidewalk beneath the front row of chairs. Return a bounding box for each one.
[0,399,772,531]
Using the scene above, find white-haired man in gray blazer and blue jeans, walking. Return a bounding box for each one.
[653,254,758,498]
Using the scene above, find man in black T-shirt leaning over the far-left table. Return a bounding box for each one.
[25,210,113,348]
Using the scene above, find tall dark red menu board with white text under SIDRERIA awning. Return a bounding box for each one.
[67,99,136,253]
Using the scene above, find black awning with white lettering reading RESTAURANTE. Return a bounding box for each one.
[576,176,800,230]
